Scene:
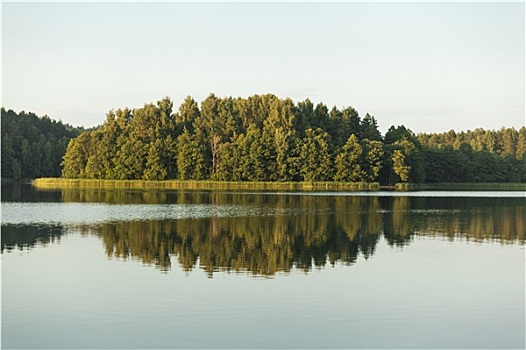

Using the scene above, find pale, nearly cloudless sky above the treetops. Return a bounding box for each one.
[2,2,525,133]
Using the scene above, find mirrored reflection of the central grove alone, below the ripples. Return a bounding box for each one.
[85,197,378,275]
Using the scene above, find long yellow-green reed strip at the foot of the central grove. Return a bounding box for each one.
[33,178,380,191]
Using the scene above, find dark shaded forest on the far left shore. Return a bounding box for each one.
[1,108,81,179]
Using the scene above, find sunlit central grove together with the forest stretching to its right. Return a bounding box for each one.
[58,94,526,184]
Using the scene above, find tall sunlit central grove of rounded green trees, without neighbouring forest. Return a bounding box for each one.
[63,94,392,182]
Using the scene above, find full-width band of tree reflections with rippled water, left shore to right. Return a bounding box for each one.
[2,185,525,276]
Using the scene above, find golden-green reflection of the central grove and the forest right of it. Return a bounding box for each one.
[79,196,524,276]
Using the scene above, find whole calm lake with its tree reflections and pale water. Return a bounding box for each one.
[2,183,526,349]
